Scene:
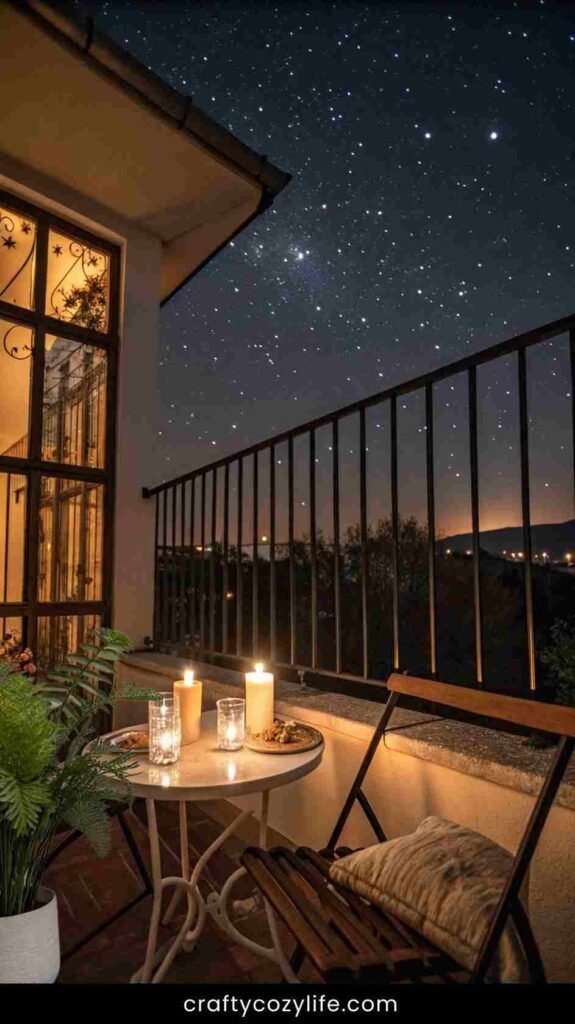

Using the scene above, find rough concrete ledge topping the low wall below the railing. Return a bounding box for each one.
[117,652,575,810]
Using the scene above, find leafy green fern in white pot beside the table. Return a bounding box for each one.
[0,630,158,983]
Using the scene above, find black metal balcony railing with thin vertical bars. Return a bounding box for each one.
[144,315,575,693]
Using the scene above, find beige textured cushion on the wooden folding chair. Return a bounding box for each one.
[330,817,529,982]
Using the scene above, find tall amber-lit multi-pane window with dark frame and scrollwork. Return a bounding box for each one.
[0,191,120,668]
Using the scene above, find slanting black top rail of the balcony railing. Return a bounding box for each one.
[143,313,575,498]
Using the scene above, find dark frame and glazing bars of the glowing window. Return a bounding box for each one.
[0,188,121,651]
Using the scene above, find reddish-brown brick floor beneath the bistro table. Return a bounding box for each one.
[46,802,312,984]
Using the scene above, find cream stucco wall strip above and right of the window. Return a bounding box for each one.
[0,154,161,645]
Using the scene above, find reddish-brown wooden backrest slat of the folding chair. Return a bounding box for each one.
[387,673,575,739]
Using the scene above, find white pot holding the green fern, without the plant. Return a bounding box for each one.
[0,887,60,985]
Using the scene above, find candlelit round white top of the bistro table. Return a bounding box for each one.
[101,711,323,801]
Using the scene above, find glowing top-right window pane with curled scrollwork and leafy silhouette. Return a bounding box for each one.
[50,241,107,331]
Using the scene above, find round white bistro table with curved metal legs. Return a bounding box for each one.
[101,711,323,983]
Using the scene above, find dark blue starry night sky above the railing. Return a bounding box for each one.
[79,0,575,532]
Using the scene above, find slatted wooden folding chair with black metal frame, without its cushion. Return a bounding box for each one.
[241,675,575,983]
